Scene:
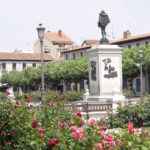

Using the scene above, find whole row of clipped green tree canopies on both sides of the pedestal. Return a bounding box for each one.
[1,45,150,88]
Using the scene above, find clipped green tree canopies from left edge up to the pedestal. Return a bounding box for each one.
[1,58,88,90]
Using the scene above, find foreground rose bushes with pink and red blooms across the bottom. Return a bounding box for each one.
[0,97,150,150]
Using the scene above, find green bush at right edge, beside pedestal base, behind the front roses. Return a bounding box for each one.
[108,96,150,128]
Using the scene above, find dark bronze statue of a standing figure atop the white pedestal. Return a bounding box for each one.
[98,10,110,44]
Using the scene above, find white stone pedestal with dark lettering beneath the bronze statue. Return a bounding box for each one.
[88,45,124,102]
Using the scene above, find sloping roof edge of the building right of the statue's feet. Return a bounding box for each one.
[110,33,150,44]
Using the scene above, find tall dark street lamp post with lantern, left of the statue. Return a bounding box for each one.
[37,24,45,103]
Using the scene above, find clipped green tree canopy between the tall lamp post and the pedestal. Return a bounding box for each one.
[47,58,88,82]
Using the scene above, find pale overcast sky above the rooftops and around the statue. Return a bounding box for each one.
[0,0,150,51]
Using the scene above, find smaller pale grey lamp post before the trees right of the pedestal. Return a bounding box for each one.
[139,49,143,99]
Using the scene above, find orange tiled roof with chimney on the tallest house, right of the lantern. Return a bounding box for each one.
[45,30,73,44]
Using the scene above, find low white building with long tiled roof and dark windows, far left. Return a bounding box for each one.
[0,52,54,76]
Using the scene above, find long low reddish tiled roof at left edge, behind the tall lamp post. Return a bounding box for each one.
[0,52,54,61]
